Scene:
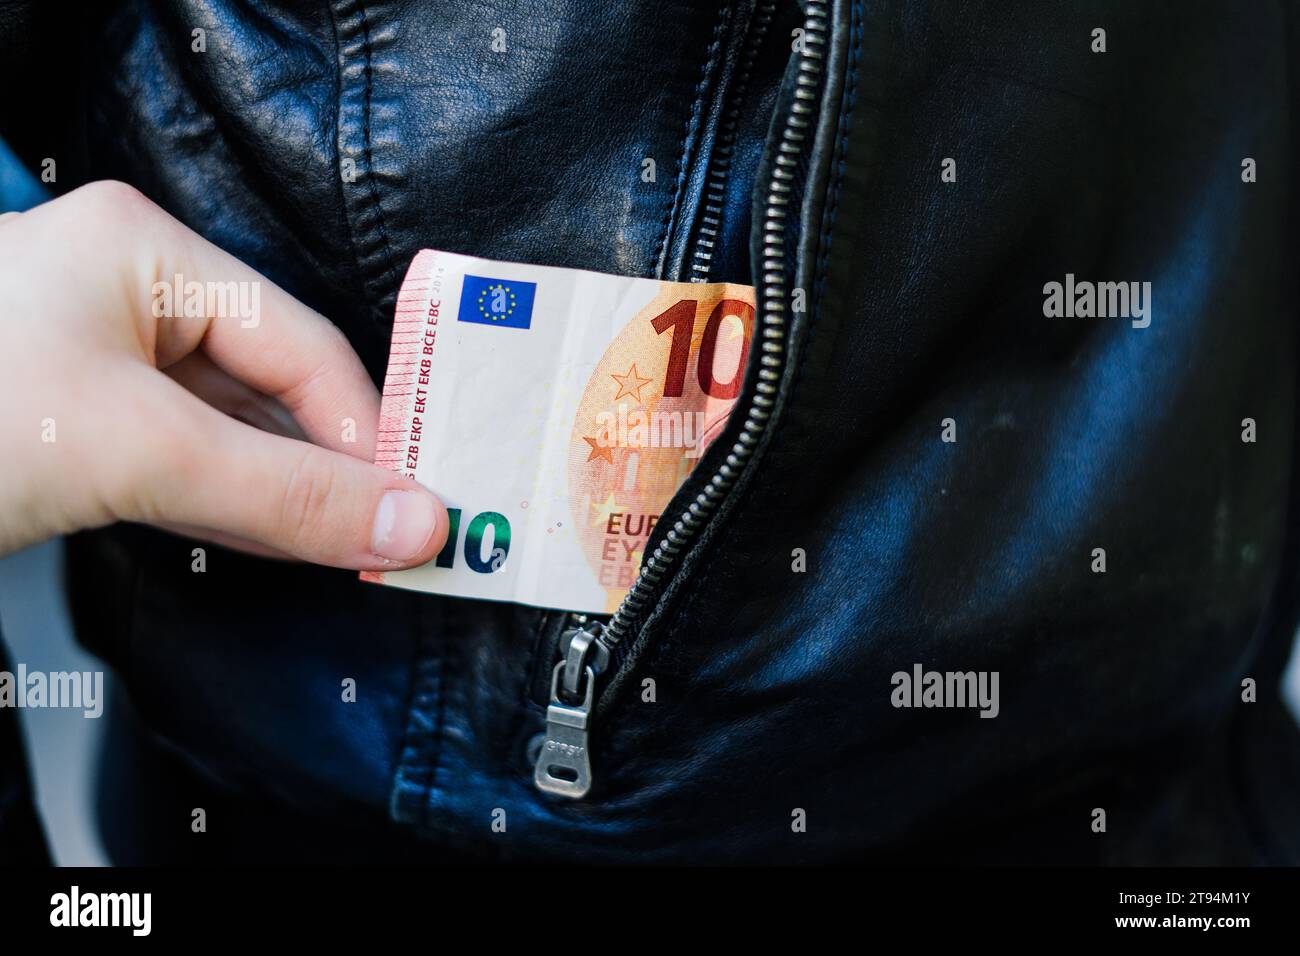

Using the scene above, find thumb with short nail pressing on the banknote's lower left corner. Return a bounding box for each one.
[120,382,447,571]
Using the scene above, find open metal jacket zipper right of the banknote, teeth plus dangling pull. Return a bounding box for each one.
[533,0,827,799]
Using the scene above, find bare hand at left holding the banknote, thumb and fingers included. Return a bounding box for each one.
[0,182,447,570]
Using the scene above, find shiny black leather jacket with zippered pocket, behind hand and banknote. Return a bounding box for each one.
[0,0,1300,862]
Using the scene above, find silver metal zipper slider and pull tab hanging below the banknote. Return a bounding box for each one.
[533,623,610,800]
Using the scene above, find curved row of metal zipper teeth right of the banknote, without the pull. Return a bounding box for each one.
[601,0,827,650]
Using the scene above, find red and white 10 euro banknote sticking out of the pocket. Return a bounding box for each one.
[363,250,754,613]
